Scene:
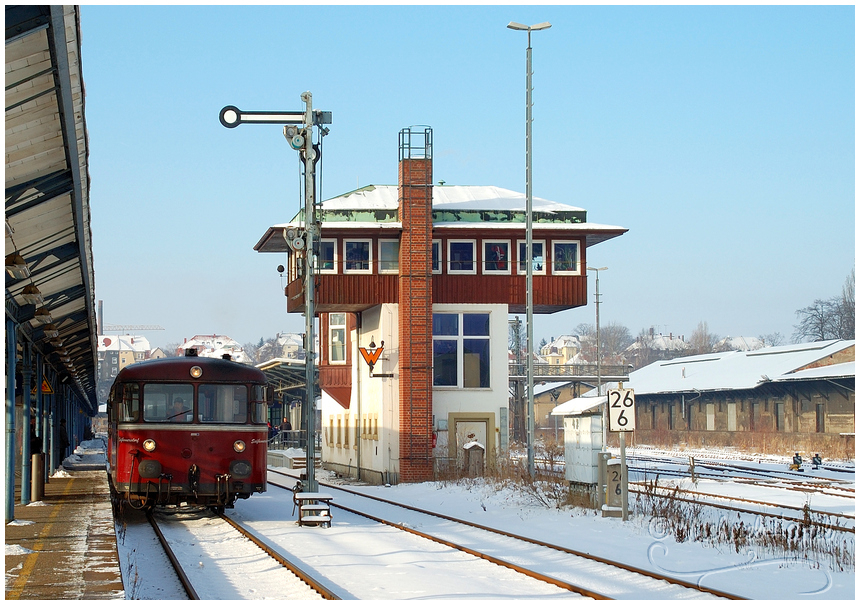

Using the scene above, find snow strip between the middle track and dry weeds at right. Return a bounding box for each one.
[308,468,854,599]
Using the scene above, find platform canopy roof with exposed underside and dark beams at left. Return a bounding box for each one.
[5,5,98,415]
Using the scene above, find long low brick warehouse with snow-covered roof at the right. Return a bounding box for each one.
[626,340,855,453]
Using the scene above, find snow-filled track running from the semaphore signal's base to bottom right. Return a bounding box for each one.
[269,469,742,599]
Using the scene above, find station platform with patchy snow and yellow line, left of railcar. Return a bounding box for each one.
[5,442,125,600]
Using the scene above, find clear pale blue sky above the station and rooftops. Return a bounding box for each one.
[81,5,855,346]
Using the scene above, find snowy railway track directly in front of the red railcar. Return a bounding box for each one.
[147,510,332,600]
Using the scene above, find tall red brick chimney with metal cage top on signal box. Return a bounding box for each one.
[398,128,433,483]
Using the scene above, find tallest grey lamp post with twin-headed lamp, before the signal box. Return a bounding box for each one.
[508,21,552,477]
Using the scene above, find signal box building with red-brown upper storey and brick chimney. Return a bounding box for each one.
[255,129,626,483]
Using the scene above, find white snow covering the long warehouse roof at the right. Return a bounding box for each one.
[627,340,854,395]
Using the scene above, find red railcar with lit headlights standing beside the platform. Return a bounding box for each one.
[108,350,271,509]
